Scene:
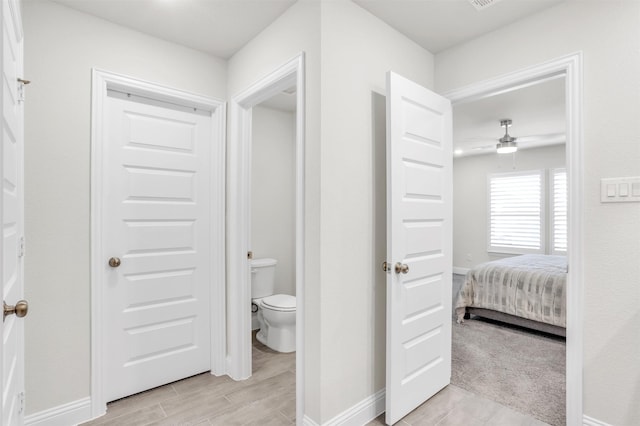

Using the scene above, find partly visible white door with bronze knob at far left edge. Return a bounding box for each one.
[0,0,27,426]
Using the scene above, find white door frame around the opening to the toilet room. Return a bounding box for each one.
[227,52,305,424]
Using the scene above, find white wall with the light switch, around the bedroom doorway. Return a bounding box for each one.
[436,0,640,425]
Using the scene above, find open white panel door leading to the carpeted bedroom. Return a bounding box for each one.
[386,72,452,424]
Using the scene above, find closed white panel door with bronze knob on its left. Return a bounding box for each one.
[102,92,211,401]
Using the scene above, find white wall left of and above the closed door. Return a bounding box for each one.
[23,0,226,414]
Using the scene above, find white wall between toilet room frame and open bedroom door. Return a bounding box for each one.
[316,1,433,422]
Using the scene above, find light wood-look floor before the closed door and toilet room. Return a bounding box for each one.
[83,333,296,426]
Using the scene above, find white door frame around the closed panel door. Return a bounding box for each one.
[91,68,226,418]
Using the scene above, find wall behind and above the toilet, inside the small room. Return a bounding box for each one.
[251,106,296,295]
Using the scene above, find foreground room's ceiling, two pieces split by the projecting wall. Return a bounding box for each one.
[51,0,565,59]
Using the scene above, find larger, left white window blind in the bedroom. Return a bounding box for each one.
[488,170,544,253]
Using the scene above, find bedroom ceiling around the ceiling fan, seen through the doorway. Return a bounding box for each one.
[453,78,565,156]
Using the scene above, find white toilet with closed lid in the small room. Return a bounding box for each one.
[251,259,296,352]
